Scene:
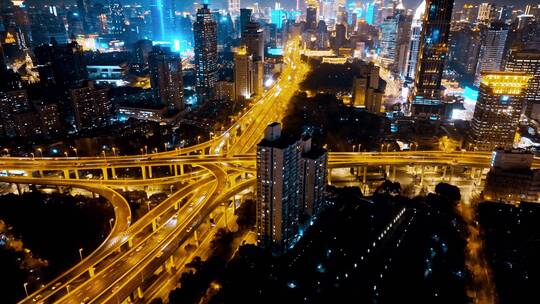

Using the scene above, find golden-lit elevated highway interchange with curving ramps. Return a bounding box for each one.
[0,39,540,304]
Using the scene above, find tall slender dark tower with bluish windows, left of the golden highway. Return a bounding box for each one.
[193,4,218,99]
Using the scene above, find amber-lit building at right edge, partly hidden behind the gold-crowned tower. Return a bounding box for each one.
[505,49,540,120]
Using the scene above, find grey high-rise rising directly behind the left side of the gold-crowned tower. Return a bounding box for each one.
[475,23,508,85]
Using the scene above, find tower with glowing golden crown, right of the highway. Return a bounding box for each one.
[466,72,530,151]
